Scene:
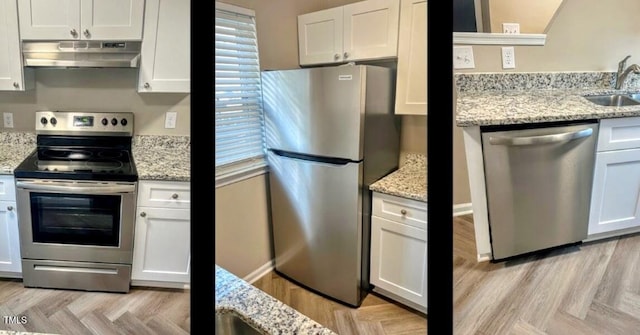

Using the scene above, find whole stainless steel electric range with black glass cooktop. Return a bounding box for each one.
[14,111,138,292]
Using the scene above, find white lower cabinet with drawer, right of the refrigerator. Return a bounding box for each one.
[370,192,427,313]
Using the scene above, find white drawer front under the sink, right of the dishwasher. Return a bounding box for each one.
[597,117,640,152]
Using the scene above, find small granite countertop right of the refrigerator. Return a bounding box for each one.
[369,154,427,202]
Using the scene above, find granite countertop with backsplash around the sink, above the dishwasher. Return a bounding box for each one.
[456,72,640,127]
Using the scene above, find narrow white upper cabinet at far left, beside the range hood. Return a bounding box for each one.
[0,0,34,91]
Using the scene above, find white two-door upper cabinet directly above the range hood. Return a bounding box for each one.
[18,0,144,41]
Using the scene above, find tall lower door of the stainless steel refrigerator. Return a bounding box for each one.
[268,152,363,306]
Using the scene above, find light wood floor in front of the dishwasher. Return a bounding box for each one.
[453,216,640,335]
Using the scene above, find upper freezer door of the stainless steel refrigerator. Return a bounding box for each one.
[262,66,366,160]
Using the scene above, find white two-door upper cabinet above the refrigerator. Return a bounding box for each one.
[298,0,400,65]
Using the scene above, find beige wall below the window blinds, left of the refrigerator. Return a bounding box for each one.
[215,174,273,278]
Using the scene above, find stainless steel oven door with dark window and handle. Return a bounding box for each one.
[16,179,136,264]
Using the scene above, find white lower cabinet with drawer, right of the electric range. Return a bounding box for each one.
[131,181,191,287]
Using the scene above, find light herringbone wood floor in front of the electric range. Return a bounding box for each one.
[0,279,190,335]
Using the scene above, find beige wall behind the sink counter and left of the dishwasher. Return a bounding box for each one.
[453,0,640,203]
